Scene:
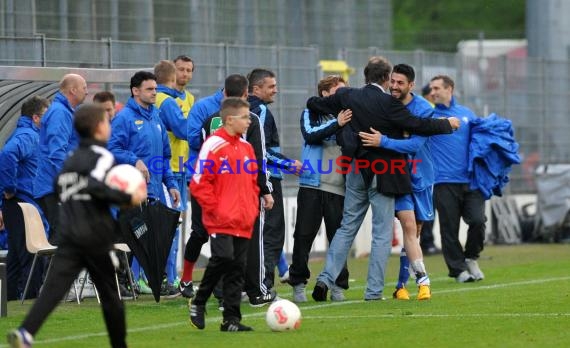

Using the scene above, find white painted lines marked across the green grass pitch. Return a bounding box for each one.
[17,277,570,347]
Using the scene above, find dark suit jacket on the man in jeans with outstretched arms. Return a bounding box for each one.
[307,85,452,195]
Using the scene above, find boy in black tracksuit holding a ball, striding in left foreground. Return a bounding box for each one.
[8,104,146,347]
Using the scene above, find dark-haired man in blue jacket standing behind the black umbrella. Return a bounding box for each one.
[107,71,180,294]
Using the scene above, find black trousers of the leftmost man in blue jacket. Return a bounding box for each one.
[2,198,44,301]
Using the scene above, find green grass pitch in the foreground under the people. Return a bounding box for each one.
[0,244,570,348]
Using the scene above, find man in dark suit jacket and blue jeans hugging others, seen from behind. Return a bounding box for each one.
[307,57,459,301]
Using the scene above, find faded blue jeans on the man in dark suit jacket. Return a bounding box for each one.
[317,162,394,300]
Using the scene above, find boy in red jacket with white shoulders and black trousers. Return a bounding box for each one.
[190,98,259,331]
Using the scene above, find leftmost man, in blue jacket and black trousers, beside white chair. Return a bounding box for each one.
[0,96,49,300]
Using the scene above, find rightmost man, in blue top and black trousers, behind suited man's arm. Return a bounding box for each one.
[430,75,486,283]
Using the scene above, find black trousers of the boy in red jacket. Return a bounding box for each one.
[192,234,249,321]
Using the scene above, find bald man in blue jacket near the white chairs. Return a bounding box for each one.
[33,74,87,244]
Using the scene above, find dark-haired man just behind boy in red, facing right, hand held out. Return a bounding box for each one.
[247,69,302,305]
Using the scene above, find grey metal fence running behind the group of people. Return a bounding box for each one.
[0,36,570,194]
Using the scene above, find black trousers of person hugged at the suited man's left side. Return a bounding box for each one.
[289,187,348,289]
